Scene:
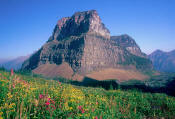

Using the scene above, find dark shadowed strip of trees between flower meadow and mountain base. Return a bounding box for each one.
[65,77,175,96]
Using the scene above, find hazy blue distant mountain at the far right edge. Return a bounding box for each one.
[149,50,175,72]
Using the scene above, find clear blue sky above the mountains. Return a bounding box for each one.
[0,0,175,58]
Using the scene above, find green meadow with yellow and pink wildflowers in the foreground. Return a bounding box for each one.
[0,71,175,119]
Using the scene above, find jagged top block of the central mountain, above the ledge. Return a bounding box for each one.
[50,10,110,40]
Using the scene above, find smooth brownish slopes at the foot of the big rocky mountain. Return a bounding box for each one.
[33,63,149,81]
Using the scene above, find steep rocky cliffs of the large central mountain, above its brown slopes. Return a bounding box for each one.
[22,10,151,79]
